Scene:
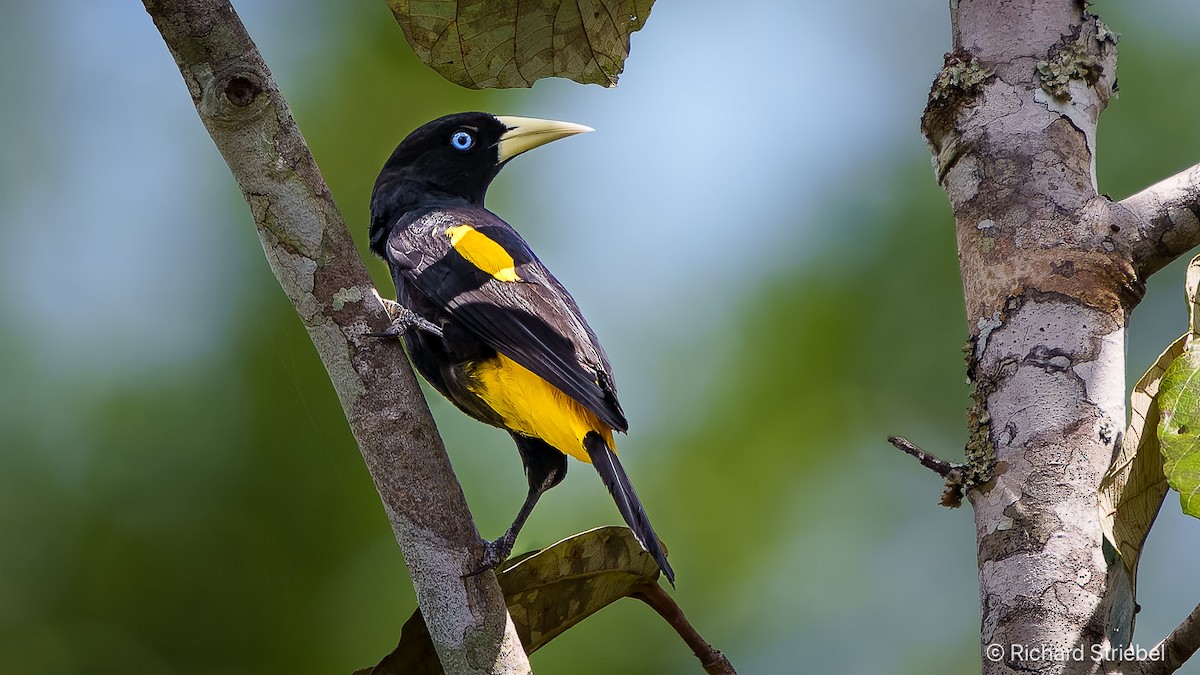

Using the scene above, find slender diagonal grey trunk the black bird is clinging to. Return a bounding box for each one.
[143,0,529,674]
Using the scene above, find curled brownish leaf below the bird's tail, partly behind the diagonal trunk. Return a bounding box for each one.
[355,527,659,675]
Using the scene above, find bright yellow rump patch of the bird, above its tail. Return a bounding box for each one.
[472,354,617,456]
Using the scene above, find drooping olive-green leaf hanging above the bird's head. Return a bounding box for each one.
[388,0,654,89]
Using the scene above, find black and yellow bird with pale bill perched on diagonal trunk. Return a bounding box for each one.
[371,113,674,584]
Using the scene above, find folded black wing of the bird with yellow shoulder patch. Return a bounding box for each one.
[386,207,629,431]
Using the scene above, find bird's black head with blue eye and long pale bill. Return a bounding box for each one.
[371,113,592,255]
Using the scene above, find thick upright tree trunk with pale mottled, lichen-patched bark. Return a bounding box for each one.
[922,0,1128,674]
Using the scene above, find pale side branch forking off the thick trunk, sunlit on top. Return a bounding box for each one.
[1120,165,1200,279]
